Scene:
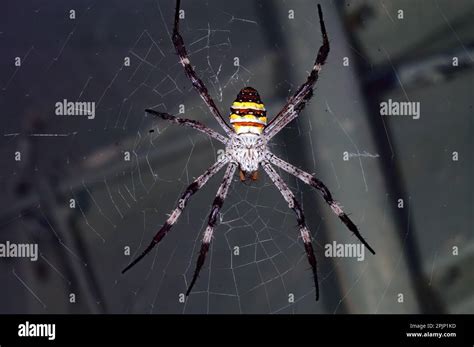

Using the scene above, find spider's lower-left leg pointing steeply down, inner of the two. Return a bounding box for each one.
[186,162,237,296]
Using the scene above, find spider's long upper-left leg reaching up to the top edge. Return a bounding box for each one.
[172,0,232,135]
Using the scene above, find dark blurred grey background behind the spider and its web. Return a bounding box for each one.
[0,0,474,313]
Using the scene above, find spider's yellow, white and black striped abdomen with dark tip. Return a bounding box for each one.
[230,87,267,134]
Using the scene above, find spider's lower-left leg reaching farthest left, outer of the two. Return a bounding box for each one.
[122,157,229,273]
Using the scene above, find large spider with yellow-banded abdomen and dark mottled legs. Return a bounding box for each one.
[122,0,375,300]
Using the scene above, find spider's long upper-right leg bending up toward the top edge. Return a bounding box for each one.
[264,4,329,139]
